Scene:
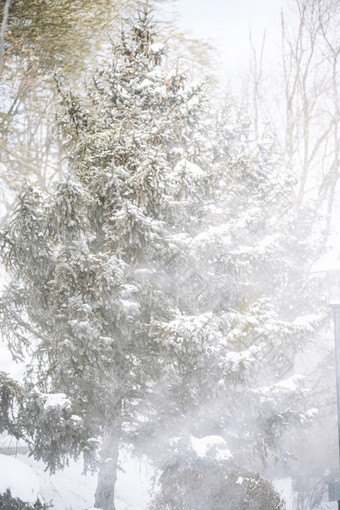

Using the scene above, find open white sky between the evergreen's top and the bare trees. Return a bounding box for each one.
[159,0,285,77]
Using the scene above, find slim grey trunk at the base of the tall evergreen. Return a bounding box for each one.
[94,416,121,510]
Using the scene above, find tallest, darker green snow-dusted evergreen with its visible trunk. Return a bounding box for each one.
[1,7,211,510]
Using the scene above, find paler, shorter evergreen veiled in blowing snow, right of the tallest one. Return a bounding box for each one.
[139,101,327,484]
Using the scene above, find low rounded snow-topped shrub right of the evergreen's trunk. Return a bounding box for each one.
[149,459,285,510]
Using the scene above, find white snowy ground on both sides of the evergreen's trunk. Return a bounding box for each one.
[0,450,153,510]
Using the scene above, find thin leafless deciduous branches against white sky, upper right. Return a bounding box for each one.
[250,0,340,231]
